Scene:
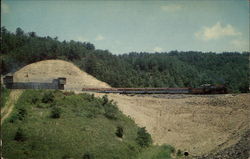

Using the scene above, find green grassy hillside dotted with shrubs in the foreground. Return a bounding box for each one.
[2,90,178,159]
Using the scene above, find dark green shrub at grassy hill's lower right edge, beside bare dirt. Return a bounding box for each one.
[136,127,152,147]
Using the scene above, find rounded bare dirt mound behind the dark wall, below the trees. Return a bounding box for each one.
[14,60,110,90]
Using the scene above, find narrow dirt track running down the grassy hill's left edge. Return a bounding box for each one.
[1,90,23,125]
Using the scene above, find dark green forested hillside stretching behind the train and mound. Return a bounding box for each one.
[1,27,249,92]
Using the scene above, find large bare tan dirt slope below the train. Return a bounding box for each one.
[93,94,250,156]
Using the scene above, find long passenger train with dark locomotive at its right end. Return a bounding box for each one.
[82,84,228,94]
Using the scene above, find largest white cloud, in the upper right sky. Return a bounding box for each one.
[195,22,241,40]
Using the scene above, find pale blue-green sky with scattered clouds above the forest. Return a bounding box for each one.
[1,0,249,54]
